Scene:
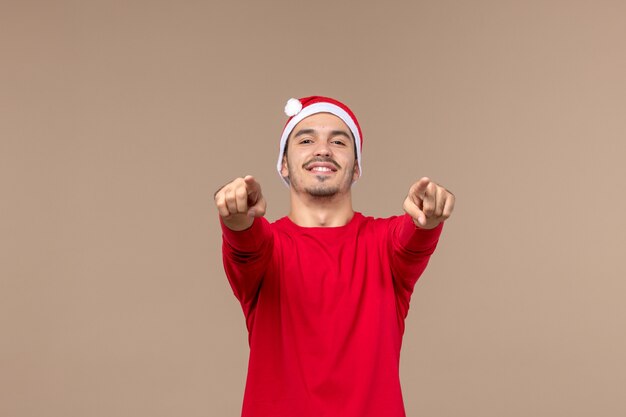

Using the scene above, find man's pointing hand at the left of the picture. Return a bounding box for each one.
[215,175,267,231]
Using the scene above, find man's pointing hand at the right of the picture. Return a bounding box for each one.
[403,177,454,229]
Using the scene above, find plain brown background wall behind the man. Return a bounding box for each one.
[0,0,626,417]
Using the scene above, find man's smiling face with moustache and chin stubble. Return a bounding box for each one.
[281,113,359,197]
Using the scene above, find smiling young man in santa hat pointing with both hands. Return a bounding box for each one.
[215,96,454,417]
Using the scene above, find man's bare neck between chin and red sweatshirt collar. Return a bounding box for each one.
[289,190,354,227]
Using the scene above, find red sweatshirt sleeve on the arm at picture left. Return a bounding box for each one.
[220,217,274,318]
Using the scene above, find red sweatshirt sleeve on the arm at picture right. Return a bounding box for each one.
[390,214,443,318]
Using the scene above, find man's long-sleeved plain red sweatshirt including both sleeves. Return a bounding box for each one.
[222,213,443,417]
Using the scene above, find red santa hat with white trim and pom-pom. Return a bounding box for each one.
[276,96,363,185]
